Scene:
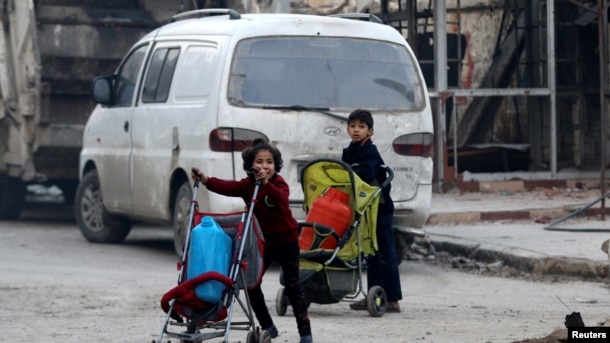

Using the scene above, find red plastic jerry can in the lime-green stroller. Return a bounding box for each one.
[299,188,352,250]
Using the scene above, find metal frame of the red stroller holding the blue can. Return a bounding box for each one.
[153,180,271,343]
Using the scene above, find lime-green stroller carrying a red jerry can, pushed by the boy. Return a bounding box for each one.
[276,159,394,317]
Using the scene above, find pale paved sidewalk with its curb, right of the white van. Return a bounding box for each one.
[424,188,610,278]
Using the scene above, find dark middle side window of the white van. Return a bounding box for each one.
[142,48,180,103]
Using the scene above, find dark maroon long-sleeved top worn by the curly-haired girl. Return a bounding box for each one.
[205,174,299,246]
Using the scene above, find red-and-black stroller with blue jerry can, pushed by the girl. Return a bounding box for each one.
[153,181,271,343]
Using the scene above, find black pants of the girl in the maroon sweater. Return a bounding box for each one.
[248,241,311,336]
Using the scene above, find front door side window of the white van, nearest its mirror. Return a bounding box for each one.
[114,45,148,107]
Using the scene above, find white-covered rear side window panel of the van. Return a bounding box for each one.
[174,45,218,101]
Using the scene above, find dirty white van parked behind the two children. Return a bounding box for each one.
[75,9,433,255]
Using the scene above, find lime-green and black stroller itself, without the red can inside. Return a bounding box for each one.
[276,158,394,317]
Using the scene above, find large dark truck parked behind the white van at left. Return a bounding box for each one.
[0,0,185,219]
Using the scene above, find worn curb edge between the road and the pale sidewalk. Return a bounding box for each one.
[432,241,610,280]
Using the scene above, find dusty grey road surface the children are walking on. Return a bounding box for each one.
[0,203,610,343]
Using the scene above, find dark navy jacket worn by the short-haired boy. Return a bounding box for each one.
[341,138,394,212]
